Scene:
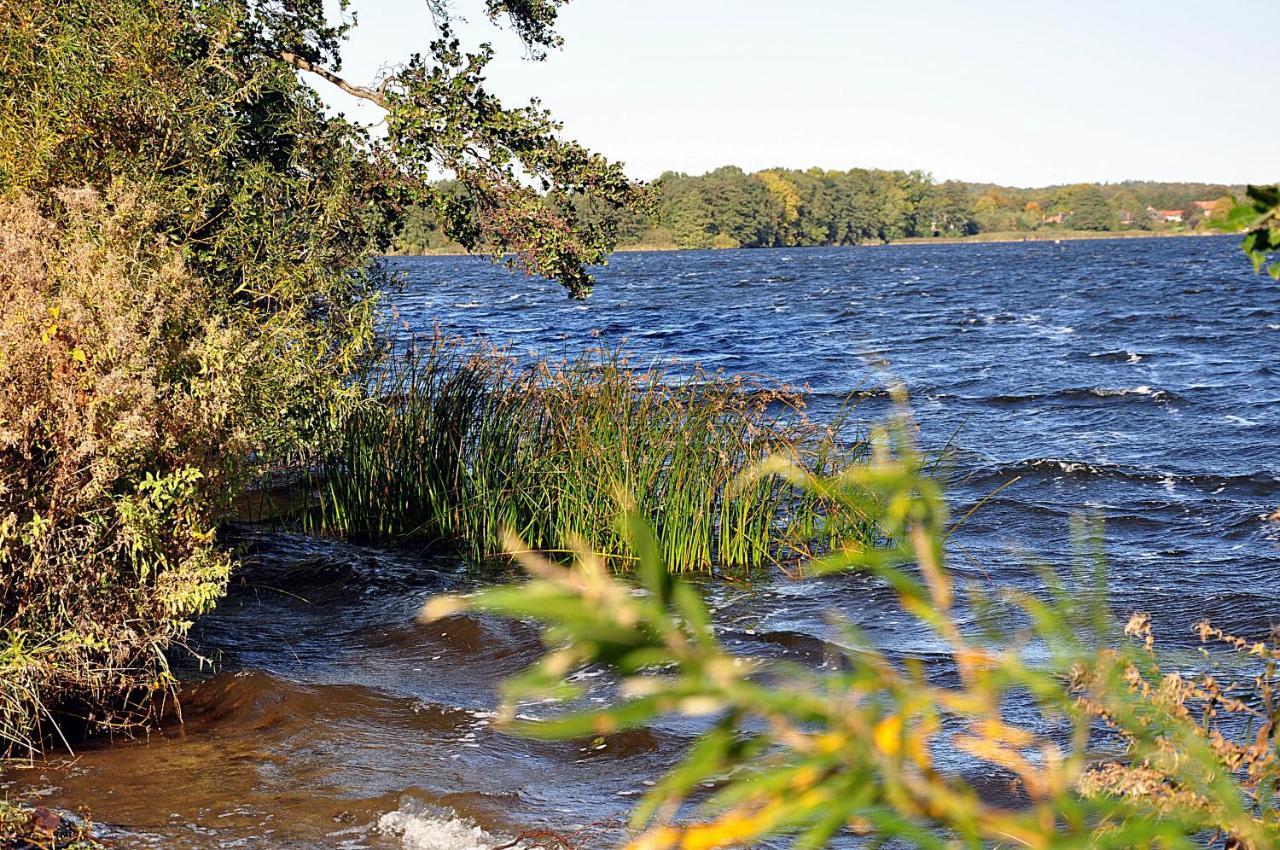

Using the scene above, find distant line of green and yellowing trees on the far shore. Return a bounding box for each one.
[399,165,1244,253]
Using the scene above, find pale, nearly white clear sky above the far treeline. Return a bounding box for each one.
[332,0,1280,186]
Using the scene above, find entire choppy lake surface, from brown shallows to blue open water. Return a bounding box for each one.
[10,238,1280,847]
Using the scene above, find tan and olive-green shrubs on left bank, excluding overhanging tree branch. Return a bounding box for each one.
[0,0,389,754]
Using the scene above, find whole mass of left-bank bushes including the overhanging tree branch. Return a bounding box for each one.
[0,0,641,742]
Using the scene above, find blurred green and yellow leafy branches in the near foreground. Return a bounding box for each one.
[424,409,1280,850]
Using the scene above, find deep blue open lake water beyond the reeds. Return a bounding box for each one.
[392,238,1280,636]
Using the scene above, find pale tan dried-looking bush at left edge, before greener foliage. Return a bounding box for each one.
[0,191,262,745]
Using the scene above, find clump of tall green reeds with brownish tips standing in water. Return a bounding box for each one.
[295,337,874,571]
